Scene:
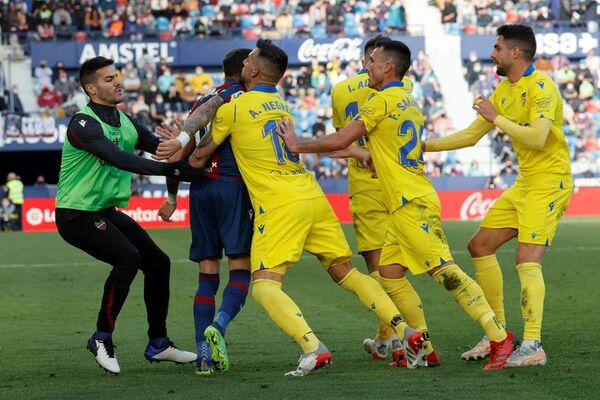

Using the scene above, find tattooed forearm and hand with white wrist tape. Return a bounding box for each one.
[153,95,225,160]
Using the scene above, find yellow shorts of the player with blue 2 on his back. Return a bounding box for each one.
[379,193,452,275]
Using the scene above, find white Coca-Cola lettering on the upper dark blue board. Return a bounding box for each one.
[298,39,362,62]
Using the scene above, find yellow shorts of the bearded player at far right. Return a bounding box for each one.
[481,176,573,246]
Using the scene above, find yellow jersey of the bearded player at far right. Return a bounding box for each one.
[488,65,571,178]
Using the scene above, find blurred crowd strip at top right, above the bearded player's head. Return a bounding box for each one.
[435,0,600,35]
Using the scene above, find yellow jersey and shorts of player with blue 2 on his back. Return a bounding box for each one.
[355,81,452,274]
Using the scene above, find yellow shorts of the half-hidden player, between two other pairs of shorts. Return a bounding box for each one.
[350,191,389,253]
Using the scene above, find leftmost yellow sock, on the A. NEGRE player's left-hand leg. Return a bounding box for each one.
[252,279,319,353]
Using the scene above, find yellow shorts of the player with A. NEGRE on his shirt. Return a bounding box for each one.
[250,197,352,272]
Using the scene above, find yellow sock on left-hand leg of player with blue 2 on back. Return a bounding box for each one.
[380,277,433,354]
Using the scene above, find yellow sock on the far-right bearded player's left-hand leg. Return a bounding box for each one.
[472,254,506,326]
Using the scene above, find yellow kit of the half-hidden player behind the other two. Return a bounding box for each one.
[331,70,413,252]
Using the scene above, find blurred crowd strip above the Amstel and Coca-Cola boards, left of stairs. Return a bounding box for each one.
[0,0,406,44]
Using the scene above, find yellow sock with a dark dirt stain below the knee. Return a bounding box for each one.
[433,265,506,342]
